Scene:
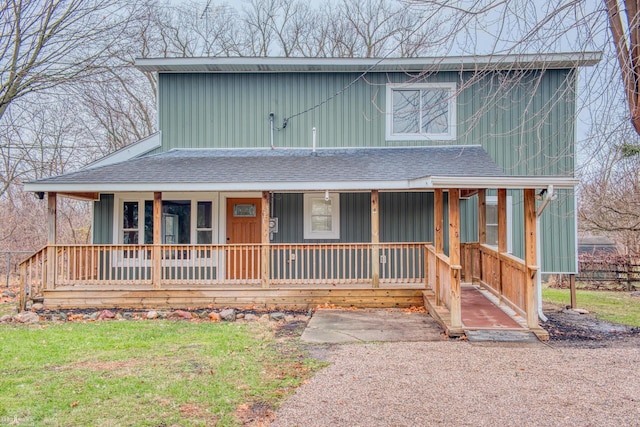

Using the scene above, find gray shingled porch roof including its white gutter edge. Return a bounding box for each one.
[25,145,576,193]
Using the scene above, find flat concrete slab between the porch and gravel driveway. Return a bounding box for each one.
[301,309,443,344]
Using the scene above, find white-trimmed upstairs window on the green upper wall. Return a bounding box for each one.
[386,83,456,141]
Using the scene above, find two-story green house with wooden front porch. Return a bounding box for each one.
[23,53,599,336]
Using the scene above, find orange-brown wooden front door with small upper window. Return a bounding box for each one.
[227,198,262,280]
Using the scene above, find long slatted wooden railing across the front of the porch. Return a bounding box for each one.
[21,243,425,295]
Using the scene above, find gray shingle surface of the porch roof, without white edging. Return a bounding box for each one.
[27,146,504,184]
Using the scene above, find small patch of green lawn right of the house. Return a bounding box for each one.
[542,288,640,327]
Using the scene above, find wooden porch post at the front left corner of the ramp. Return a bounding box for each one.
[449,188,462,328]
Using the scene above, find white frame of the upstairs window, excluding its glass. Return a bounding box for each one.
[386,82,457,141]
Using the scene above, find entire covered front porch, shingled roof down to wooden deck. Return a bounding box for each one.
[21,146,575,335]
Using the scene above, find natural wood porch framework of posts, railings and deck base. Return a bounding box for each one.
[21,188,539,335]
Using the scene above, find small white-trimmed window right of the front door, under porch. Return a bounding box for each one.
[304,193,340,239]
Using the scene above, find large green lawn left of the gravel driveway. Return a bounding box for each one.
[0,320,319,426]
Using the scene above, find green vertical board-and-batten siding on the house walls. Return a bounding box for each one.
[138,70,575,272]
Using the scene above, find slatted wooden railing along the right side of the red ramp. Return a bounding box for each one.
[461,243,527,316]
